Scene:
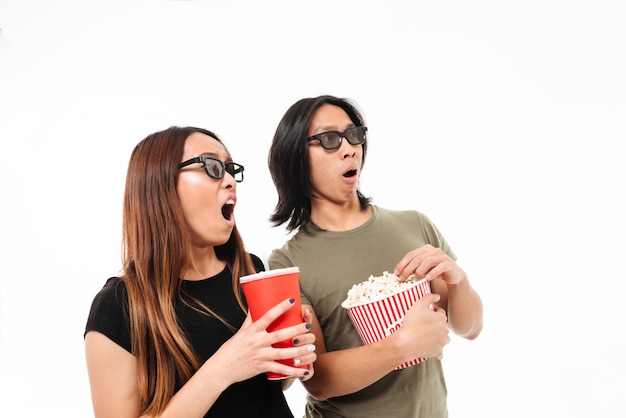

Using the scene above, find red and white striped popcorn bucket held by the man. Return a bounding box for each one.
[341,279,430,370]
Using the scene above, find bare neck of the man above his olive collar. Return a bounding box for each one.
[311,198,372,232]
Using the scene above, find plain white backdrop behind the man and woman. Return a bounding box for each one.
[0,0,626,418]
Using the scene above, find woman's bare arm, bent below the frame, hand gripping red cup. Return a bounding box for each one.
[85,300,316,418]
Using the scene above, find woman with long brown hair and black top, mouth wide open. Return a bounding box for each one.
[85,127,316,418]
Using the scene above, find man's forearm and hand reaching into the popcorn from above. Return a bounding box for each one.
[394,245,483,340]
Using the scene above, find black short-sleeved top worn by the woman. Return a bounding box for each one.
[85,255,293,418]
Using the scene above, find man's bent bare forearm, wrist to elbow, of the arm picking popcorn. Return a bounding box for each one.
[447,277,483,340]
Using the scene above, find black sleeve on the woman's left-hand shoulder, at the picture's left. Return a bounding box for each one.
[84,277,132,353]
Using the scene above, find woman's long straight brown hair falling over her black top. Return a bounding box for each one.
[123,126,254,414]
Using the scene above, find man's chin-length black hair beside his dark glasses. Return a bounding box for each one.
[268,95,371,232]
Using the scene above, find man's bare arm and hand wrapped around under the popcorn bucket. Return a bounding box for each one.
[303,294,450,400]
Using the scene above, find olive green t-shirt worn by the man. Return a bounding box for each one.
[268,205,456,418]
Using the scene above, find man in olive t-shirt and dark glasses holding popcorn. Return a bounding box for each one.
[268,96,482,418]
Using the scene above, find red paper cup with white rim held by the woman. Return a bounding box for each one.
[239,267,308,380]
